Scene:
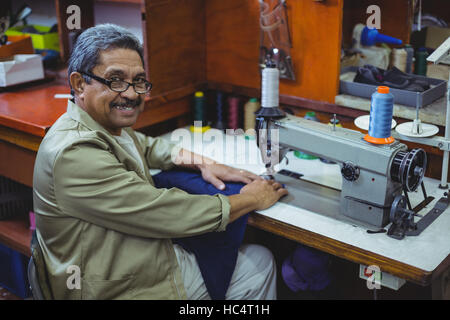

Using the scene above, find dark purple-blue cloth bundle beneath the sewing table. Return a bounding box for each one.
[281,244,332,292]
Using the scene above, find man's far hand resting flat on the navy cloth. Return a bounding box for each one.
[200,163,263,190]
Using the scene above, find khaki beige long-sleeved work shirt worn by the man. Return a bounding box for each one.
[33,101,230,299]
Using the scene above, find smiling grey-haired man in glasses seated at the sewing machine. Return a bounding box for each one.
[32,24,287,299]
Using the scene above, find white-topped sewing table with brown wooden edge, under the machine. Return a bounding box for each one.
[154,129,450,297]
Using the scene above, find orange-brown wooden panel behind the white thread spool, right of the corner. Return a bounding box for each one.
[206,0,343,102]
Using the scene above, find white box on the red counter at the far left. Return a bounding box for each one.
[0,54,44,87]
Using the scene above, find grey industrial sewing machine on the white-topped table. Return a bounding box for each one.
[256,63,449,239]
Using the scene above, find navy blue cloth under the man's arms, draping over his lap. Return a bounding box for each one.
[153,170,248,300]
